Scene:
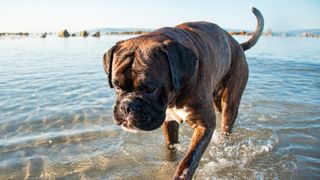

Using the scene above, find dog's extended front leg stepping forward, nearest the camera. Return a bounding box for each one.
[173,120,215,180]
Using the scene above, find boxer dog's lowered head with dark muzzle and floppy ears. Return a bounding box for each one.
[103,36,197,131]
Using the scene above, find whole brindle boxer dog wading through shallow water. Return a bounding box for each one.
[103,8,264,179]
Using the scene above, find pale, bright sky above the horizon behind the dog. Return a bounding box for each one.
[0,0,320,32]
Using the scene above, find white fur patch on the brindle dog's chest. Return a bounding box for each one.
[166,107,191,123]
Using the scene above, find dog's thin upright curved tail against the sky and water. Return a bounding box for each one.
[241,7,264,51]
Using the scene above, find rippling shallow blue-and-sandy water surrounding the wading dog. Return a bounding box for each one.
[0,36,320,179]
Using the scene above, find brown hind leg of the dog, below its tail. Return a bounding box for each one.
[221,53,248,135]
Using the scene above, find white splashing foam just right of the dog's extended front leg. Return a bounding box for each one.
[200,130,278,174]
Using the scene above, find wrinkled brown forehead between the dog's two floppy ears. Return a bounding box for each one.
[112,40,166,90]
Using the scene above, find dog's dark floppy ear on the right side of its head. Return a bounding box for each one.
[162,41,198,91]
